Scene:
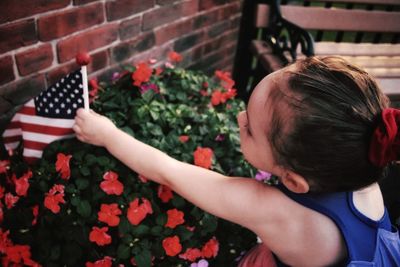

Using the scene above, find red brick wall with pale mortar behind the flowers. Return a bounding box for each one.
[0,0,242,129]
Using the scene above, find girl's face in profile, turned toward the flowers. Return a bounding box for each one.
[238,69,285,176]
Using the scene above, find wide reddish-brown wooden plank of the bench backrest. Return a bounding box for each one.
[281,6,400,32]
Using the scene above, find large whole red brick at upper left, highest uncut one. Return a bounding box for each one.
[38,3,104,41]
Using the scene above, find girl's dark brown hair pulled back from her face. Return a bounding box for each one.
[268,57,389,192]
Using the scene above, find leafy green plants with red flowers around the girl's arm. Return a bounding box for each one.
[0,53,256,267]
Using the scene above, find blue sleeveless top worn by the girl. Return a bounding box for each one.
[278,185,400,267]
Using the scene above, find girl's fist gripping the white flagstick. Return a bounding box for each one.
[73,108,117,146]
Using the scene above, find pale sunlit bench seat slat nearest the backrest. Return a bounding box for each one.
[312,42,400,56]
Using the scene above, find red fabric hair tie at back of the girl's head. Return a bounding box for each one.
[369,108,400,167]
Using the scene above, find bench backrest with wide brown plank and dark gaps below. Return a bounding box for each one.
[255,0,400,43]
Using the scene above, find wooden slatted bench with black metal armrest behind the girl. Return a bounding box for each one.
[233,0,400,101]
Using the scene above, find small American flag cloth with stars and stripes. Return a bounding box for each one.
[3,68,86,164]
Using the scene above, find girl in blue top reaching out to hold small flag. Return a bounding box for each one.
[74,57,400,267]
